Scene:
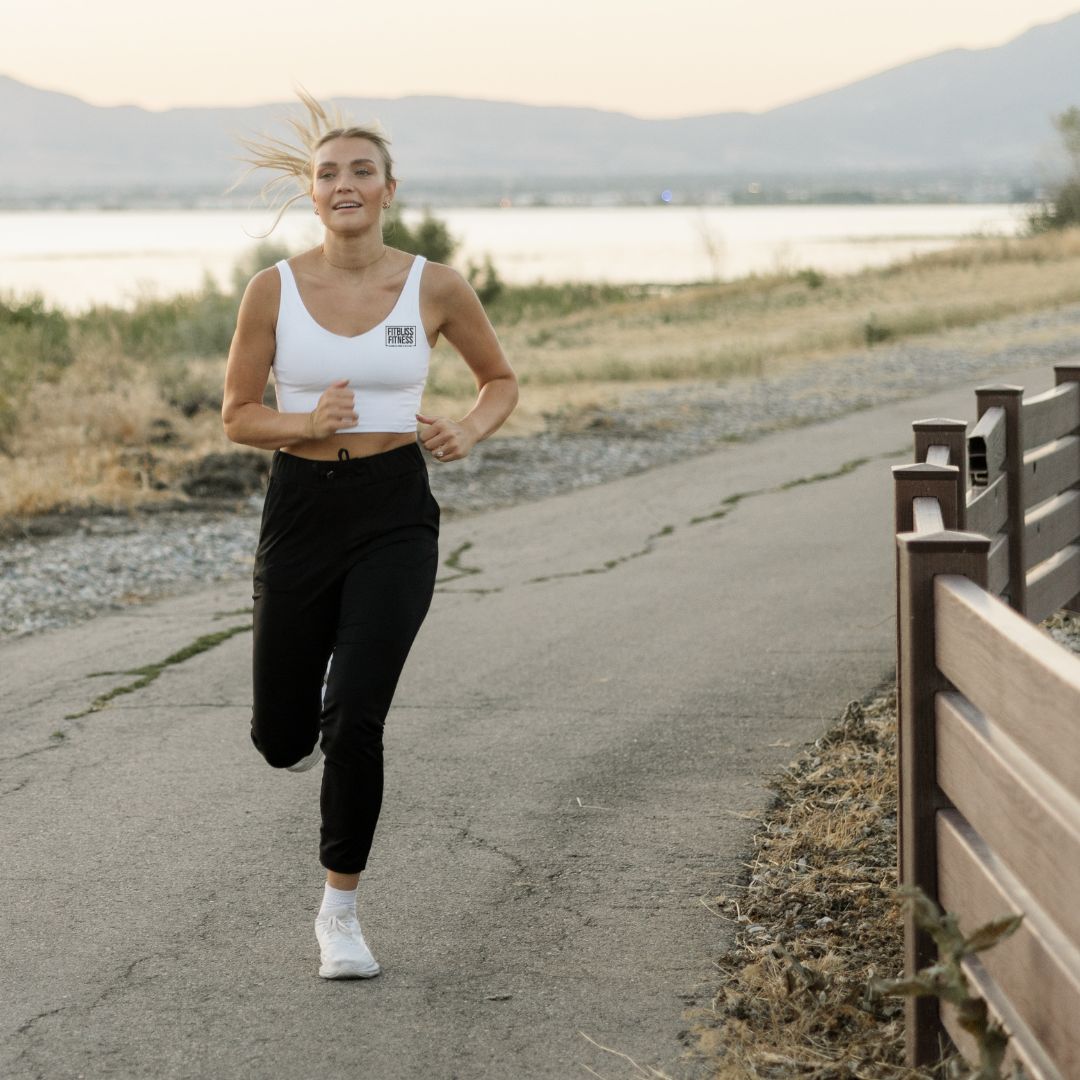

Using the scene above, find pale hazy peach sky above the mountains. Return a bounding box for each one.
[8,0,1080,117]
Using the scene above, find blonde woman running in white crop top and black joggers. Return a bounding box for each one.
[221,95,517,978]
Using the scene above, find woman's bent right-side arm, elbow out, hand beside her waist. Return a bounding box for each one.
[417,262,517,461]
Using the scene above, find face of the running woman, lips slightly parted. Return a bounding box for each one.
[311,137,397,231]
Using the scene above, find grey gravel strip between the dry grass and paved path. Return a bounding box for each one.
[0,305,1080,638]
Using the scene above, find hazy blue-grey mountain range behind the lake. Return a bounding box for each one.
[0,12,1080,202]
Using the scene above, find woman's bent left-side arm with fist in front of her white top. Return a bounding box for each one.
[221,267,356,450]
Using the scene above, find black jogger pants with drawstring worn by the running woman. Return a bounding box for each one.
[252,443,438,874]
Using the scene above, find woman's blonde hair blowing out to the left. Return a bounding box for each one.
[228,86,395,237]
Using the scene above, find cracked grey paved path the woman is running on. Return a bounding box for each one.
[0,370,1049,1080]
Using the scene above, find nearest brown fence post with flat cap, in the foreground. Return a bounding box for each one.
[896,532,990,1066]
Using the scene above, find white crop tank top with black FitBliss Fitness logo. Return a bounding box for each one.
[273,255,431,432]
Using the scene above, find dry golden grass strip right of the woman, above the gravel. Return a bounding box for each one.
[421,229,1080,421]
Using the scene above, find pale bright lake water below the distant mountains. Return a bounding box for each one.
[0,205,1026,310]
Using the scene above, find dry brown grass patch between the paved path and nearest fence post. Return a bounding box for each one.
[687,691,932,1080]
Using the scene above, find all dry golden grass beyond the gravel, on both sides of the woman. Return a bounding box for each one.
[0,230,1080,518]
